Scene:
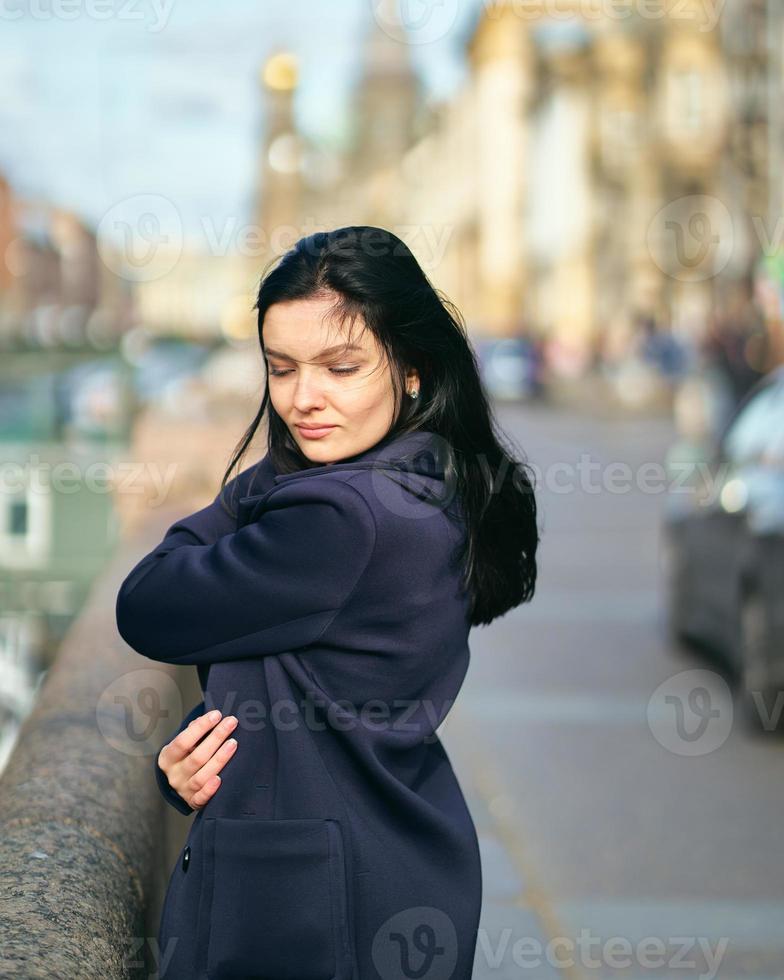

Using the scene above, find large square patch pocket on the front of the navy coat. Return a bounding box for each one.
[201,817,351,980]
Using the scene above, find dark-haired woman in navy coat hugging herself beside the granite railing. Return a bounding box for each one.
[117,226,538,980]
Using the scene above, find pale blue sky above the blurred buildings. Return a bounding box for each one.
[0,0,480,244]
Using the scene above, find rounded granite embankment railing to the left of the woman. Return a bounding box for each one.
[0,508,200,980]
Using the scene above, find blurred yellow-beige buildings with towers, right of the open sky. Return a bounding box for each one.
[258,0,782,373]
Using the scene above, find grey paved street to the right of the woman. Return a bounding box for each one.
[441,408,784,980]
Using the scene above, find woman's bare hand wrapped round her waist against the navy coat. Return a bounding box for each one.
[158,711,237,810]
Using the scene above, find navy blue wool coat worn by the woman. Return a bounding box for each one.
[116,431,482,980]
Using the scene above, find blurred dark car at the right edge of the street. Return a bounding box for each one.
[663,366,784,731]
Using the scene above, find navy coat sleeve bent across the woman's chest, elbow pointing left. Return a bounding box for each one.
[116,475,376,664]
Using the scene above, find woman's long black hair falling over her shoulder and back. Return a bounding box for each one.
[221,225,539,626]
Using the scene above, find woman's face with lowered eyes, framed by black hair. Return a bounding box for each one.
[262,294,418,464]
